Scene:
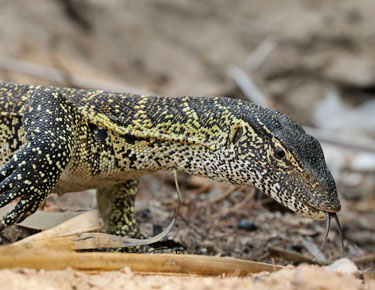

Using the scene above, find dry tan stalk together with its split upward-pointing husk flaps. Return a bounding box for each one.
[0,211,282,276]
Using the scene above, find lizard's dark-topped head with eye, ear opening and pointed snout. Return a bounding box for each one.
[223,103,341,219]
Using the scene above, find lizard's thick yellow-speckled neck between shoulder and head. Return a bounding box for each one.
[97,96,250,182]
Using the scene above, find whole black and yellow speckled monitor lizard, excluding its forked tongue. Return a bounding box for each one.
[0,83,340,245]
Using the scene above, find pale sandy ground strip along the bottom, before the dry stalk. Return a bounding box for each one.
[0,265,375,290]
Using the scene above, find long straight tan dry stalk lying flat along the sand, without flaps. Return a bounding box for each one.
[0,246,282,276]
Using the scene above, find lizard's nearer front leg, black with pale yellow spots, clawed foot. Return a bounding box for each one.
[0,90,77,230]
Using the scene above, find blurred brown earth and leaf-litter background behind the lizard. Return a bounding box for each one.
[0,0,375,267]
